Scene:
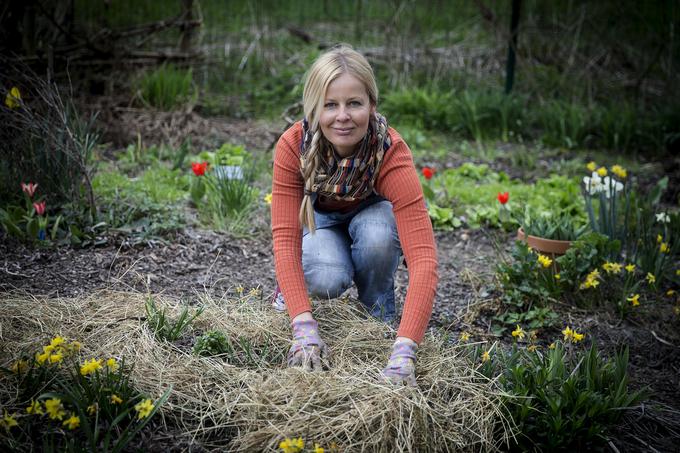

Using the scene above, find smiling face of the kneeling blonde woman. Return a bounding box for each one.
[319,73,375,157]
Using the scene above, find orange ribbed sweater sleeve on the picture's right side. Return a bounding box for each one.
[376,129,439,343]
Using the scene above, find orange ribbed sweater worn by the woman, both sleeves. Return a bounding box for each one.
[271,122,438,343]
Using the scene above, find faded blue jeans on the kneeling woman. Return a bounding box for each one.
[302,196,401,322]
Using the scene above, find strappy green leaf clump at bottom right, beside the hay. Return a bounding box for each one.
[481,340,645,451]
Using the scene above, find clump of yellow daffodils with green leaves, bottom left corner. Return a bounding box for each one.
[0,336,171,452]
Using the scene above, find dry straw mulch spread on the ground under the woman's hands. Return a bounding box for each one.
[0,291,510,452]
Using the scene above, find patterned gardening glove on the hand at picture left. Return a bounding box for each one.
[288,319,329,371]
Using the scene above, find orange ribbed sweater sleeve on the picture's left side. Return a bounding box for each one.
[271,123,312,319]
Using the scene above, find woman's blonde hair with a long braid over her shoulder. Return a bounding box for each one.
[299,44,378,233]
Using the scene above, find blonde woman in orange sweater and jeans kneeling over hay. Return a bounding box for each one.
[271,46,438,385]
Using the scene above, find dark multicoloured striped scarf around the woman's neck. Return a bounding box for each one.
[300,113,392,201]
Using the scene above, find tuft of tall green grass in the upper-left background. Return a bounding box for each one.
[138,63,196,110]
